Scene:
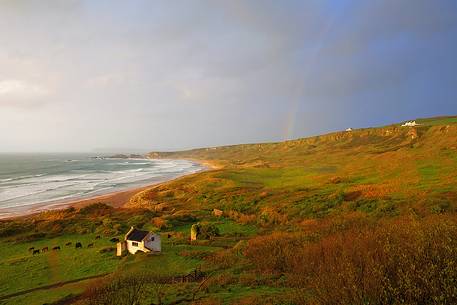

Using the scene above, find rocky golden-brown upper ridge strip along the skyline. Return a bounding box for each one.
[147,116,457,163]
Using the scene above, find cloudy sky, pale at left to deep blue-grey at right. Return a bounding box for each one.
[0,0,457,152]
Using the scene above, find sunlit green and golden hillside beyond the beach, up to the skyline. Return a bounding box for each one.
[140,116,457,218]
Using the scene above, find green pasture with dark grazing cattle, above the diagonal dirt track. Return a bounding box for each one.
[0,234,119,296]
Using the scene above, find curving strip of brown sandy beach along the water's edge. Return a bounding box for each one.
[0,159,221,221]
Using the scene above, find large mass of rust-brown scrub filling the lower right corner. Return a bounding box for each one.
[245,217,457,304]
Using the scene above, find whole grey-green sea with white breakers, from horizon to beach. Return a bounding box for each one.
[0,154,204,218]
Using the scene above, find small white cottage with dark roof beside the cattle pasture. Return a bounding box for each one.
[117,227,162,256]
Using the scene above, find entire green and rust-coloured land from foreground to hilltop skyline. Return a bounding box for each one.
[0,117,457,305]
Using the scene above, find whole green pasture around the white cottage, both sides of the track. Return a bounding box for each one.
[0,213,256,304]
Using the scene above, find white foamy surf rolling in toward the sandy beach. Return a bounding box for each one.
[0,159,201,210]
